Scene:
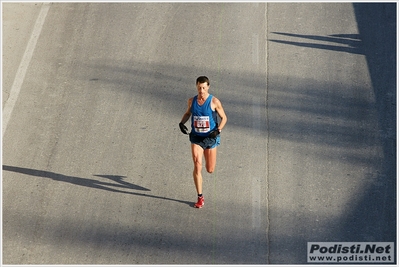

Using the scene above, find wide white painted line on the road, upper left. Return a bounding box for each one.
[2,3,51,136]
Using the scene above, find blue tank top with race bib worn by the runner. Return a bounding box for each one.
[191,95,217,136]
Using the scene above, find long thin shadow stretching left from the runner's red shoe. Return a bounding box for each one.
[3,165,193,205]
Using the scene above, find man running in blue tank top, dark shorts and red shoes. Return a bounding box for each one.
[179,76,227,208]
